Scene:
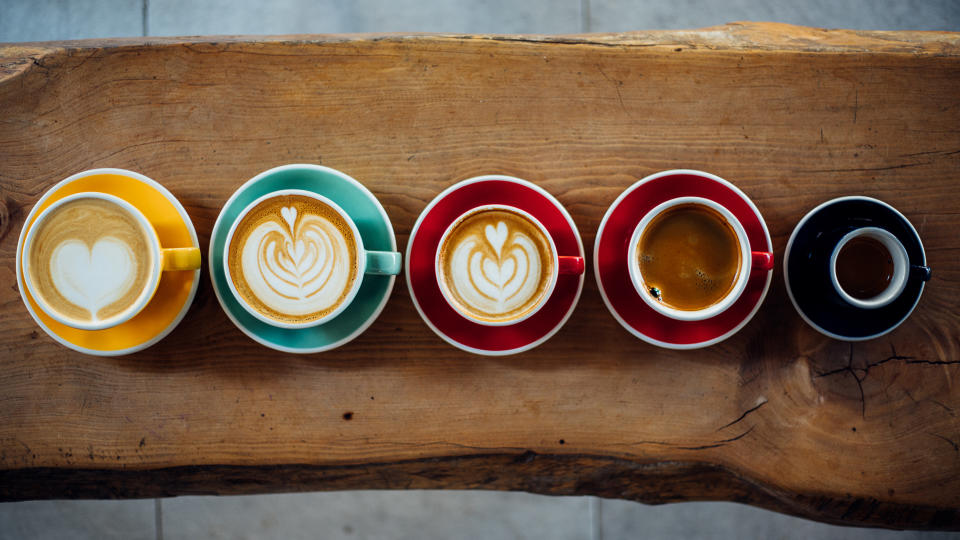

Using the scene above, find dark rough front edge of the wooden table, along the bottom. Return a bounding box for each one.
[0,450,960,530]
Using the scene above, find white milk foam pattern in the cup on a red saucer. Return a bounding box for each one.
[450,221,542,317]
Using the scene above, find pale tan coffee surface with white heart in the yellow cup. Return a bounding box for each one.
[26,198,155,323]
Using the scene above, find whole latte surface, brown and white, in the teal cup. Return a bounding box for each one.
[228,195,357,323]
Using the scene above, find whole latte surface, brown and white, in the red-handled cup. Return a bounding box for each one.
[440,209,554,322]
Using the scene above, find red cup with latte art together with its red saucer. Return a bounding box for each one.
[405,174,584,356]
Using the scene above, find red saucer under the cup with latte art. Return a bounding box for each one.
[406,176,584,355]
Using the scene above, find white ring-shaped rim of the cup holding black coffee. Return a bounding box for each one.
[627,197,752,321]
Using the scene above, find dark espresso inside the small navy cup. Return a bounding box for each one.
[837,236,893,300]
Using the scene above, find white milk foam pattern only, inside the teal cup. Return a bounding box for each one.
[241,206,353,316]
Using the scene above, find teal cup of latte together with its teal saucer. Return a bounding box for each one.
[209,165,401,352]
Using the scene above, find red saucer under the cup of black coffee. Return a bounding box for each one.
[593,170,773,349]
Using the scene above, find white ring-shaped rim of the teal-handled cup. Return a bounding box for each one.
[223,189,367,329]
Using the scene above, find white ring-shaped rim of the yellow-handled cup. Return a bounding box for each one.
[21,192,163,330]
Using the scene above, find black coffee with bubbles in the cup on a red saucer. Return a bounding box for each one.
[637,204,741,311]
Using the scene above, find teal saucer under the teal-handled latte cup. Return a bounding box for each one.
[207,164,397,353]
